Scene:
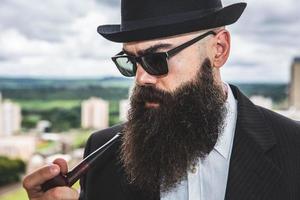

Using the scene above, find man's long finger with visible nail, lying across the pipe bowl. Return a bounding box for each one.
[23,164,60,190]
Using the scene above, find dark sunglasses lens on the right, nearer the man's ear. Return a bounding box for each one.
[141,53,168,75]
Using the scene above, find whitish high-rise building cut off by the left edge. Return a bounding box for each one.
[0,95,22,136]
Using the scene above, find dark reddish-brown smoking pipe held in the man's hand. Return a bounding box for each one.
[41,133,121,192]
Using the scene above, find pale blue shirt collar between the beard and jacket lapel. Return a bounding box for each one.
[214,83,237,160]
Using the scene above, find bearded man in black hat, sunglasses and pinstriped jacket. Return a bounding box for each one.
[24,0,300,200]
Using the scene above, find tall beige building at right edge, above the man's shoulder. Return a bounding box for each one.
[289,57,300,110]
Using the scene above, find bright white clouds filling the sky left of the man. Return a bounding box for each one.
[0,0,120,77]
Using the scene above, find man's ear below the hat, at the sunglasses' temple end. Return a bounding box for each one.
[213,29,230,68]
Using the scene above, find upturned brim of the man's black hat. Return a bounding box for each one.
[97,3,247,43]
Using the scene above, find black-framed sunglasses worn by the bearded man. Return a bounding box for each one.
[111,31,216,77]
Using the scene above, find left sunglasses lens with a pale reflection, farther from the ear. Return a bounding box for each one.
[113,56,136,77]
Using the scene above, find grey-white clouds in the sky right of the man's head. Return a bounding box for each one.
[223,0,300,82]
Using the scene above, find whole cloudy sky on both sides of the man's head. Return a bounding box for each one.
[0,0,300,82]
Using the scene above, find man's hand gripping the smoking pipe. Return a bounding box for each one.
[23,159,79,200]
